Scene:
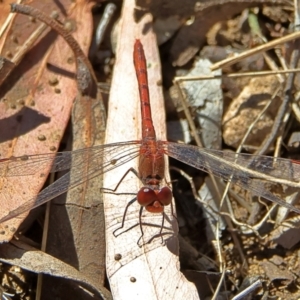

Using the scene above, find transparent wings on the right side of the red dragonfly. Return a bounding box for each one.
[164,143,300,214]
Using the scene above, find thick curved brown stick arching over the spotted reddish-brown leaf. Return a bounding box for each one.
[11,3,97,93]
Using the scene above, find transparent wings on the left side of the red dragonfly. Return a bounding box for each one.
[0,141,140,223]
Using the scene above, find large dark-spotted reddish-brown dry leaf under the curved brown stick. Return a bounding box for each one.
[0,1,90,241]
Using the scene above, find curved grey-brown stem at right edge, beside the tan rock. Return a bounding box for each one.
[254,41,300,155]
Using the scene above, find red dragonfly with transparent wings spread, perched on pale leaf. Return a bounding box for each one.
[0,40,300,223]
